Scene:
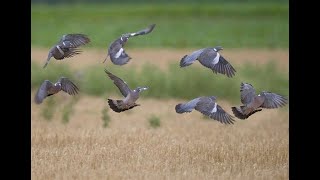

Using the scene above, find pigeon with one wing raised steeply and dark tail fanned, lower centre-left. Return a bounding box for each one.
[105,69,148,113]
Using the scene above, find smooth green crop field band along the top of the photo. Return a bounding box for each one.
[31,3,289,48]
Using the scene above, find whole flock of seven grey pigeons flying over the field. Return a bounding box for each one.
[35,24,287,124]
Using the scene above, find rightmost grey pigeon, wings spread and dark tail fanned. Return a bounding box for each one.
[231,82,287,119]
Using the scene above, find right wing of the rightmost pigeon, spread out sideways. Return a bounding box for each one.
[260,91,287,109]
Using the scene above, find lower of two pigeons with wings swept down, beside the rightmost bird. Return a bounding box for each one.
[175,96,235,124]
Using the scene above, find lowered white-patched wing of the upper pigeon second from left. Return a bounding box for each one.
[109,42,131,65]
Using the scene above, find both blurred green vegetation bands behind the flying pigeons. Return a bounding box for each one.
[31,0,289,102]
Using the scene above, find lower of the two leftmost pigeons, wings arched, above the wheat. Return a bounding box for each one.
[34,77,79,104]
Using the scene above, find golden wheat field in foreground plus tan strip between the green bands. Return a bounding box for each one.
[31,48,289,180]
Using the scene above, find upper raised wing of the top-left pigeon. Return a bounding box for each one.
[59,34,90,48]
